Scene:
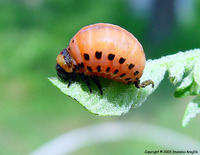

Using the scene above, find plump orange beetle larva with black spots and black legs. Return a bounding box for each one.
[56,23,154,94]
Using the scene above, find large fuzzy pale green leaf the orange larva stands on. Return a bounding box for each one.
[49,49,200,116]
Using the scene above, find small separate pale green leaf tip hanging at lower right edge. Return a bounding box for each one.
[182,95,200,127]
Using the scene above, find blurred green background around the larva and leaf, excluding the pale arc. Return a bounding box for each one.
[0,0,200,155]
